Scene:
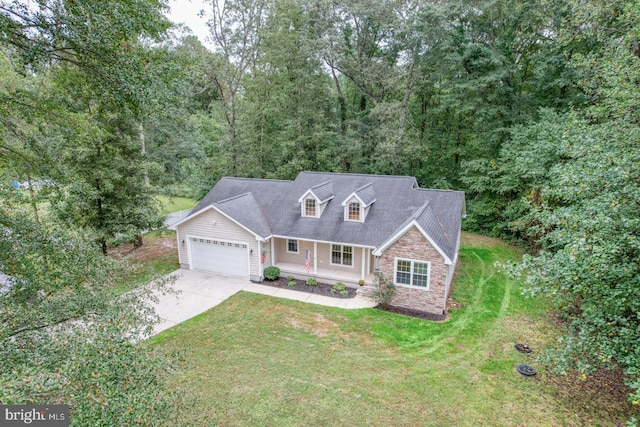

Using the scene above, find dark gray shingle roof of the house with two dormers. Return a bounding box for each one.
[189,172,464,259]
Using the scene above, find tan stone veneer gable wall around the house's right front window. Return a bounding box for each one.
[380,227,447,314]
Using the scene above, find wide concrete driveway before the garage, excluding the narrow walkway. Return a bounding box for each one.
[153,269,251,335]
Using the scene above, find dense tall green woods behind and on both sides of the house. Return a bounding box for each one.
[0,0,640,422]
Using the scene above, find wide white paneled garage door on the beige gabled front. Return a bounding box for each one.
[189,237,249,277]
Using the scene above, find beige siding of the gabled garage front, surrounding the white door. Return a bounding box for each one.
[176,209,260,280]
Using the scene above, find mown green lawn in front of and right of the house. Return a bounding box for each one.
[149,235,629,426]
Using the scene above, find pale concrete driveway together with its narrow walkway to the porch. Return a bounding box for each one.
[149,269,376,335]
